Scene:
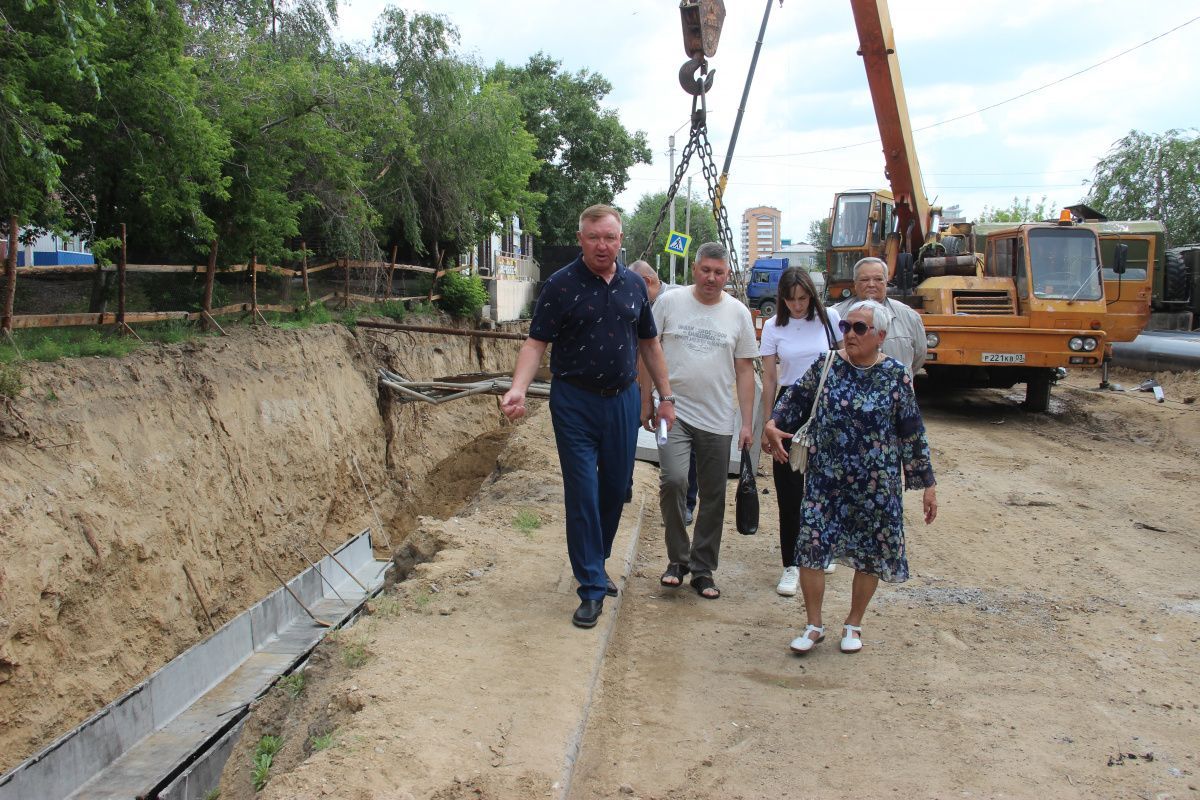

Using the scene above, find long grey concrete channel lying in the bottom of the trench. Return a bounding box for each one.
[0,531,386,800]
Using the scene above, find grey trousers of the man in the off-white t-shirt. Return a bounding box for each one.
[659,420,733,576]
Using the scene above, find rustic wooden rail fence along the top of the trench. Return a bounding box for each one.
[0,217,458,336]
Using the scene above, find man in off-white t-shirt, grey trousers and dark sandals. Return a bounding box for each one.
[642,242,758,600]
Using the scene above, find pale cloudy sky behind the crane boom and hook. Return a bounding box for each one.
[338,0,1200,250]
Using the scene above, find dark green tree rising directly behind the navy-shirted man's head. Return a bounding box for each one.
[490,53,650,245]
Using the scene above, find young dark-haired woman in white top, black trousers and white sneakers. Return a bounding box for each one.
[760,266,839,597]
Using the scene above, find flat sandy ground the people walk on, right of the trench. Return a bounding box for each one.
[221,373,1200,800]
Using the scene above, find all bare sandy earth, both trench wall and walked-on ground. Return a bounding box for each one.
[0,321,1200,800]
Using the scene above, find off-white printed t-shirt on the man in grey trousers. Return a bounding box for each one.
[652,287,758,435]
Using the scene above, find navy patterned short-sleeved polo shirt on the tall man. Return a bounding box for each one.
[529,254,659,389]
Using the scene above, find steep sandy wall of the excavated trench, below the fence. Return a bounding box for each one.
[0,325,518,796]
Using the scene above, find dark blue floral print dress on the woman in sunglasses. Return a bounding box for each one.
[772,354,935,583]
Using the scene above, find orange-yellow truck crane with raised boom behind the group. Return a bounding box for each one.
[826,0,1132,411]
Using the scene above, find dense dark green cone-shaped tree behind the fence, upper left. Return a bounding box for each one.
[61,0,229,260]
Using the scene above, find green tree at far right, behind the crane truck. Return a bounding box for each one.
[1085,128,1200,245]
